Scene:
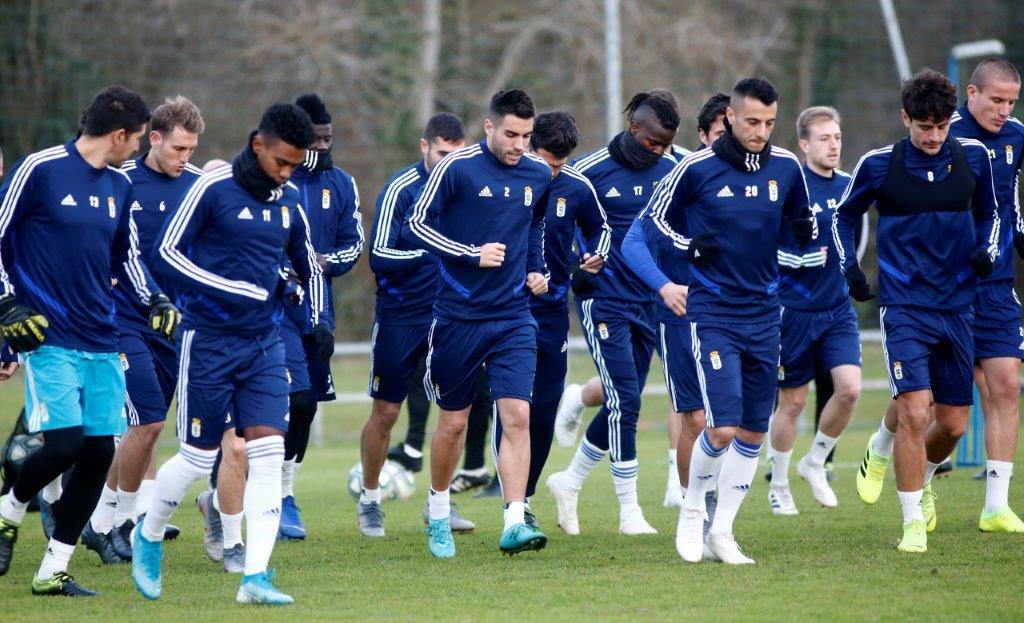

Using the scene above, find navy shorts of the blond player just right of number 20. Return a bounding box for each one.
[778,303,860,387]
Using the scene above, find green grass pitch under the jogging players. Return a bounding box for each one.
[0,346,1024,623]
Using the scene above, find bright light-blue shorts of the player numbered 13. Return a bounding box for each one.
[20,344,126,437]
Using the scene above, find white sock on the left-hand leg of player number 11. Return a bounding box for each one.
[142,444,217,541]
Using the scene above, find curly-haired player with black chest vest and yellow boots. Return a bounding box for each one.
[833,70,1000,552]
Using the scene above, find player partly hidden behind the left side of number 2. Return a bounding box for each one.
[355,113,475,537]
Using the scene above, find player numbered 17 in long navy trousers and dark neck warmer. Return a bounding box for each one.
[547,87,679,535]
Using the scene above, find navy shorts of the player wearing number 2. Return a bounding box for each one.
[423,312,537,411]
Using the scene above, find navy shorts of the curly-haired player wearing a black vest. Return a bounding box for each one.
[879,306,974,406]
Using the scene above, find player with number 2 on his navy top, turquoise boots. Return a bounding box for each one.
[408,89,551,557]
